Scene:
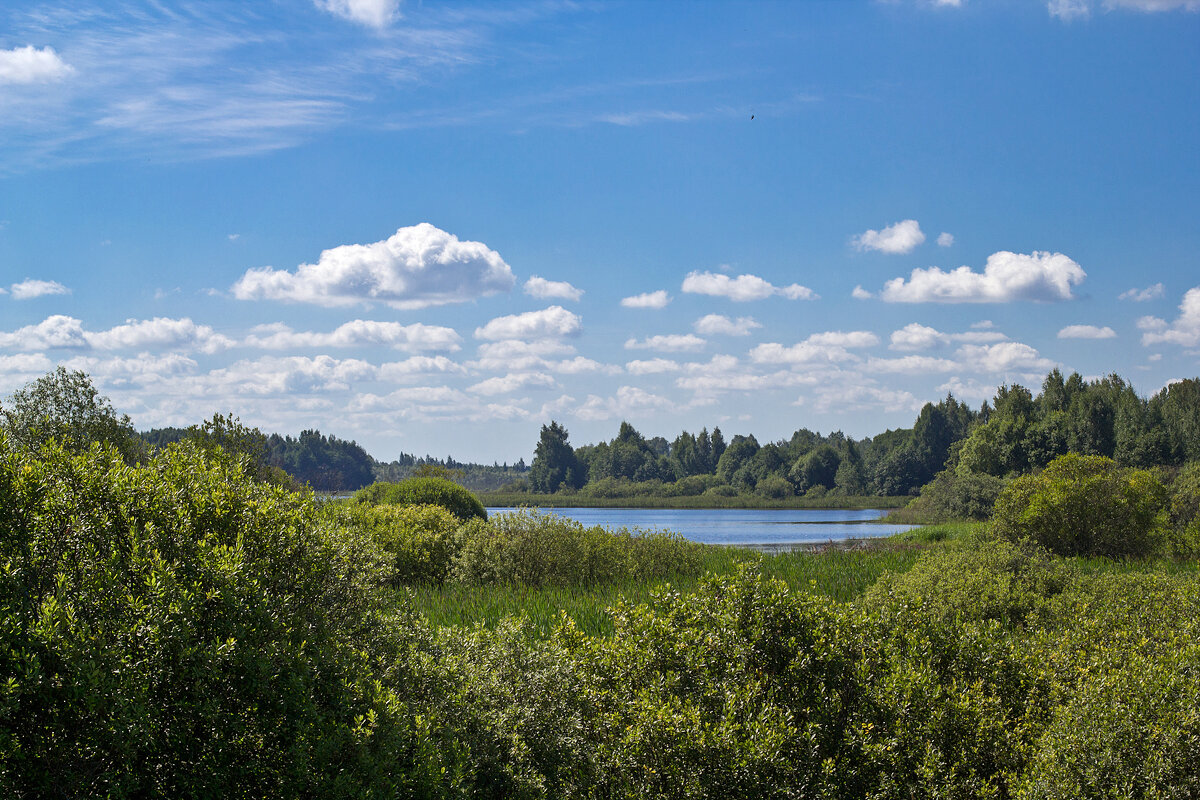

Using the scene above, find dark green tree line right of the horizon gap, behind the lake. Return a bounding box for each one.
[523,369,1200,498]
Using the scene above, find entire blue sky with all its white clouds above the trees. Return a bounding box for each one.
[0,0,1200,462]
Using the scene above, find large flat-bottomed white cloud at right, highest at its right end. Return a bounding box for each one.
[881,251,1086,302]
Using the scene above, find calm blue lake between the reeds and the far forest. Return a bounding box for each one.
[487,509,916,549]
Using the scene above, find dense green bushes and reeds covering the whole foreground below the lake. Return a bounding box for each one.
[0,440,1200,799]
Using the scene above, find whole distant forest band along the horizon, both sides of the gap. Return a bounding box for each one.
[139,369,1200,501]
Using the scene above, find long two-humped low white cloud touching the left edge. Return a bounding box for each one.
[0,314,234,353]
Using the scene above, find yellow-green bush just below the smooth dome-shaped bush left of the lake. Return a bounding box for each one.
[332,504,462,584]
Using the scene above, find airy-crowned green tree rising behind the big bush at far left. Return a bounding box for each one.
[0,366,145,463]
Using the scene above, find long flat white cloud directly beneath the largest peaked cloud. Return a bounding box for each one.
[244,319,462,353]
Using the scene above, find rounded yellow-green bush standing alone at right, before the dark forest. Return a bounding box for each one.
[991,455,1166,558]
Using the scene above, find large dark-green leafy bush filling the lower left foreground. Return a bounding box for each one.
[0,438,458,798]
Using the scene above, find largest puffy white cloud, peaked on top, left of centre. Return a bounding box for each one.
[233,222,516,309]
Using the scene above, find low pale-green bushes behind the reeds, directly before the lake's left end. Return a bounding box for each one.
[451,511,704,587]
